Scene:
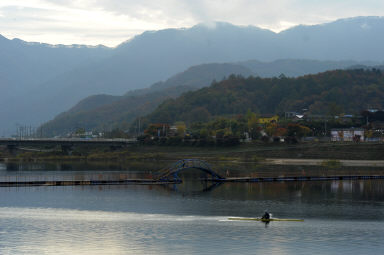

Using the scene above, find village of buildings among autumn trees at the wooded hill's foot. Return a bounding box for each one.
[134,109,384,145]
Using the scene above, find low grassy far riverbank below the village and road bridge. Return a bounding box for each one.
[0,143,384,167]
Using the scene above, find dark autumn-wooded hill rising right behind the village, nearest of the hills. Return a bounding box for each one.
[145,69,384,123]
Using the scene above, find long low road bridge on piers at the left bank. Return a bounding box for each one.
[0,138,137,152]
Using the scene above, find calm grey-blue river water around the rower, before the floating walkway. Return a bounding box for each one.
[0,162,384,255]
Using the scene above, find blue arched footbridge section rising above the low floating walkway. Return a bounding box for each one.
[156,159,225,180]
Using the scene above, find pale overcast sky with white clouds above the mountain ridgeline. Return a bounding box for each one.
[0,0,384,46]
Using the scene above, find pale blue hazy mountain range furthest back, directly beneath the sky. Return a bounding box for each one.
[0,17,384,135]
